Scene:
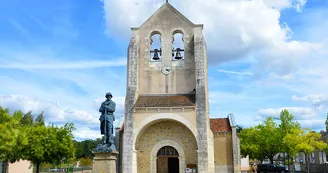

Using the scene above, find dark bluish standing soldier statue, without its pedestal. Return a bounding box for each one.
[99,92,116,146]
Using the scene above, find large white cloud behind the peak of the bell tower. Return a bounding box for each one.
[102,0,321,74]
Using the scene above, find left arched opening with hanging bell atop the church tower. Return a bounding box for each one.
[150,31,162,61]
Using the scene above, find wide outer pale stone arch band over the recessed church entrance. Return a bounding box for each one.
[133,113,198,150]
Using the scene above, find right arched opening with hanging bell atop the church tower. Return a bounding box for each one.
[172,31,185,60]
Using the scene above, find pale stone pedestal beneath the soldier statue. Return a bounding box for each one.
[92,151,118,173]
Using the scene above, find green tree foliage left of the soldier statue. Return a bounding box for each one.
[0,107,75,173]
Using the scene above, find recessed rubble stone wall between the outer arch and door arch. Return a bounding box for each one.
[135,121,197,173]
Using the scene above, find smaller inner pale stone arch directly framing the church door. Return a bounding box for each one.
[150,140,186,173]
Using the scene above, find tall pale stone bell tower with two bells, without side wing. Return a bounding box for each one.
[121,1,214,173]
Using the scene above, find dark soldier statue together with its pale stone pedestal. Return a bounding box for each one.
[92,92,118,173]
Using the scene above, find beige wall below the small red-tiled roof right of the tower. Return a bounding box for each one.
[214,133,233,173]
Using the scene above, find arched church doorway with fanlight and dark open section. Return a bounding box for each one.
[156,146,179,173]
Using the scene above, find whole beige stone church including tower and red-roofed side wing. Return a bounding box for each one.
[116,2,240,173]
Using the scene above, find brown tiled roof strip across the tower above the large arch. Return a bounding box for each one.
[135,94,195,107]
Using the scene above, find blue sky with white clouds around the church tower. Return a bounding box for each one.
[0,0,328,140]
